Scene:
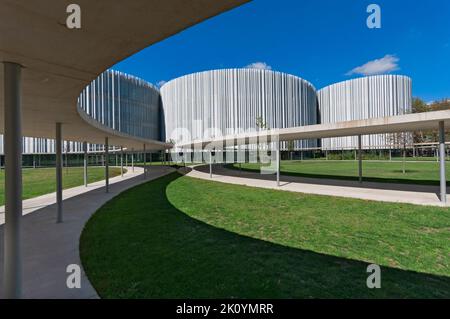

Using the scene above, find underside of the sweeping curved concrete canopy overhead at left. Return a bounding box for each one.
[0,0,248,150]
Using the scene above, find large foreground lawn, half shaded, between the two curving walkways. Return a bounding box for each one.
[80,173,450,298]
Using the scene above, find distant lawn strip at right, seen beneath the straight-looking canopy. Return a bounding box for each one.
[232,161,450,185]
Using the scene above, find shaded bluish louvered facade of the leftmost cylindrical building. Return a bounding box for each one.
[0,70,161,154]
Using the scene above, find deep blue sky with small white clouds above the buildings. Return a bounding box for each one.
[113,0,450,101]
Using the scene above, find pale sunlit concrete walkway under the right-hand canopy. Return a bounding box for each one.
[187,165,449,207]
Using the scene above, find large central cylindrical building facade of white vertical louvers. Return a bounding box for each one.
[161,69,317,149]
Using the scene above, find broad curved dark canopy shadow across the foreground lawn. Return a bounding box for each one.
[80,173,450,298]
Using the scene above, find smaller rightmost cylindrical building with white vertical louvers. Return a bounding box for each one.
[318,75,412,150]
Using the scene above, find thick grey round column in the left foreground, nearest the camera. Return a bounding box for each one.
[3,62,22,299]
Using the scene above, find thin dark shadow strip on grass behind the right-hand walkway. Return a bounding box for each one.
[224,164,442,186]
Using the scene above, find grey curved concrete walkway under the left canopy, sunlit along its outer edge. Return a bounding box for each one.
[0,166,173,299]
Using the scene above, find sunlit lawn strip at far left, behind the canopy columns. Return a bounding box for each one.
[0,167,120,205]
